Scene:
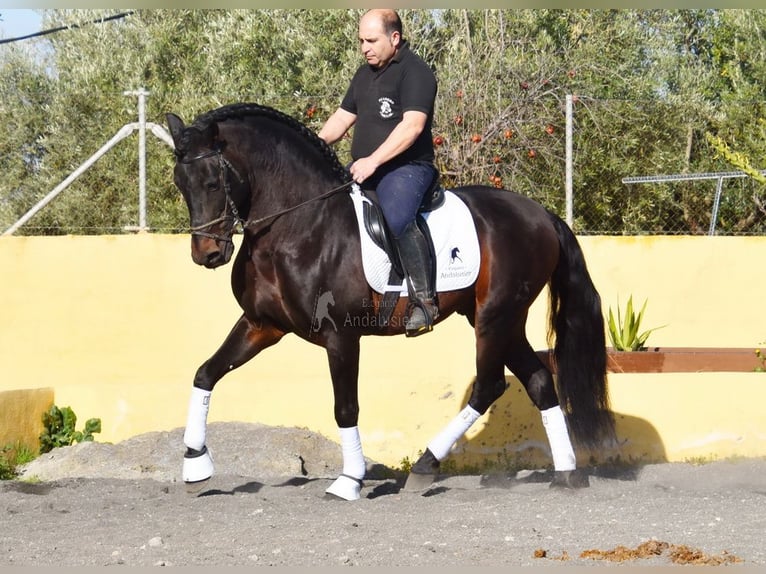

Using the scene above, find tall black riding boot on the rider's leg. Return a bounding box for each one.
[396,221,439,337]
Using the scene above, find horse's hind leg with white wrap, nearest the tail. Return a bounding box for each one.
[506,337,588,488]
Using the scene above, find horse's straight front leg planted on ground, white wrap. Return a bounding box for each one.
[325,337,367,500]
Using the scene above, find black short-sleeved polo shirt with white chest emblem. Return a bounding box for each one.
[341,41,437,168]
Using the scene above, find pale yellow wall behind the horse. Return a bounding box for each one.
[0,234,766,472]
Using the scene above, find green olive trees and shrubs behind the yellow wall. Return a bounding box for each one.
[0,9,766,234]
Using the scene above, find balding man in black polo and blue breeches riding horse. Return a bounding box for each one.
[319,10,439,337]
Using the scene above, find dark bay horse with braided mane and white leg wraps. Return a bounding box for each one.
[166,102,614,500]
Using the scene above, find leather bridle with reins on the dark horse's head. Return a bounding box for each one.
[178,145,354,243]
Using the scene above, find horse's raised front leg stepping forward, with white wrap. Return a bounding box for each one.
[182,315,284,491]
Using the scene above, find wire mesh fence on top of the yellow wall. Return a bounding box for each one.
[0,94,766,235]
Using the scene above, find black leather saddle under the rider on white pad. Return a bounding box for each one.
[362,176,445,326]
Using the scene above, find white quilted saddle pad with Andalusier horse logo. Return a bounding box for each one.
[349,184,480,295]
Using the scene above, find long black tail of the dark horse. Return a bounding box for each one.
[548,213,615,448]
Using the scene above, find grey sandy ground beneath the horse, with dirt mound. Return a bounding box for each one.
[0,423,766,567]
